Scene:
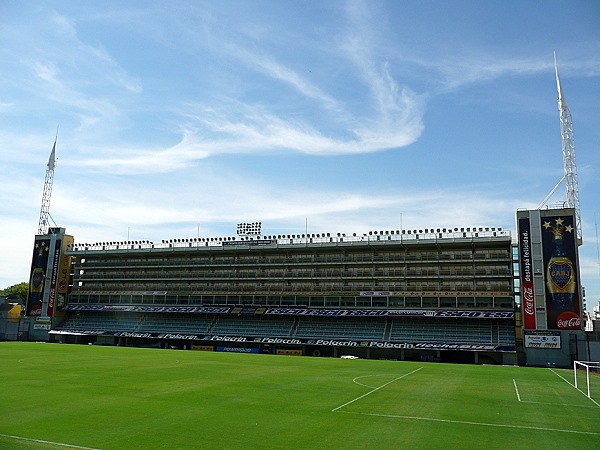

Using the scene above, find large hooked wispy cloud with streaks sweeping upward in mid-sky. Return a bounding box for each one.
[52,0,424,173]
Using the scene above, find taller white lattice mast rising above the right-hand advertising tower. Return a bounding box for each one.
[538,52,583,245]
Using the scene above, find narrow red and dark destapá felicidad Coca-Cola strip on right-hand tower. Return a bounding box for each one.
[518,218,536,330]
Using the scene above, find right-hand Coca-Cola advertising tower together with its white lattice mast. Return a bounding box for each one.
[517,54,583,339]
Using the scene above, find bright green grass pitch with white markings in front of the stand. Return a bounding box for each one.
[0,342,600,450]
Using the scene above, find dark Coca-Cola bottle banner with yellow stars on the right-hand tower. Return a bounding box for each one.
[541,214,581,330]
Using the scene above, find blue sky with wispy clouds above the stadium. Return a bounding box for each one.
[0,0,600,309]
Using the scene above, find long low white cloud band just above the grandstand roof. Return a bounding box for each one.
[52,164,526,240]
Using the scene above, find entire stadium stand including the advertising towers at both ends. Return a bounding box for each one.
[16,208,600,367]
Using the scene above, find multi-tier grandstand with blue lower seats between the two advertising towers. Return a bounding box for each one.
[47,228,518,364]
